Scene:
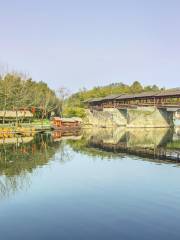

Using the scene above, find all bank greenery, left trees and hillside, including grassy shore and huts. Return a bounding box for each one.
[0,72,177,131]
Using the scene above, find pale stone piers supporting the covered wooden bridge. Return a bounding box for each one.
[85,107,174,128]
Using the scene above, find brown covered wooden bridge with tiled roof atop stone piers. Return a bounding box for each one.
[86,88,180,111]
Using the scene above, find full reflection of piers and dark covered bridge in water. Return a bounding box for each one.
[71,128,180,162]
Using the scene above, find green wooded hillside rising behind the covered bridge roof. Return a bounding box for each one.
[64,81,162,117]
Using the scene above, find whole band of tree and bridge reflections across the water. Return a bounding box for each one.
[0,128,180,198]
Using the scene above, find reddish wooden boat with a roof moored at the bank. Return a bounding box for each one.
[51,117,81,131]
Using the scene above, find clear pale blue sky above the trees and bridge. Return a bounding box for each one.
[0,0,180,92]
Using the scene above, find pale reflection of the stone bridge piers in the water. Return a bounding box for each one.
[84,127,172,148]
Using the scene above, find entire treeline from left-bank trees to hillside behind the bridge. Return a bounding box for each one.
[0,73,165,118]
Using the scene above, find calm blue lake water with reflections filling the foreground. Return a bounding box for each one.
[0,129,180,240]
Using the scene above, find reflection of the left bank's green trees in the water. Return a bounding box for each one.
[0,133,70,199]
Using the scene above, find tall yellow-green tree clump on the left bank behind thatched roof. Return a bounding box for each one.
[0,73,62,118]
